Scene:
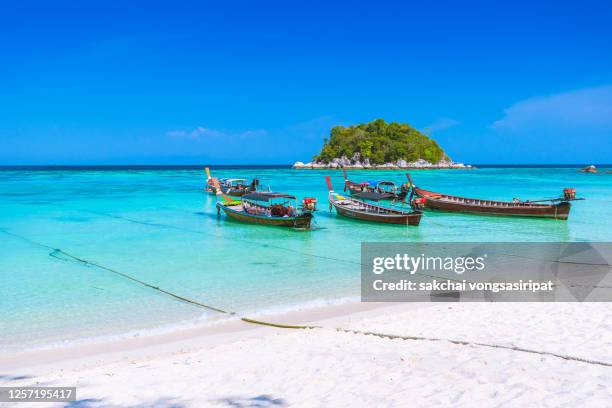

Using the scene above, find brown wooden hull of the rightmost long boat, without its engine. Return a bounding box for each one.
[416,189,571,220]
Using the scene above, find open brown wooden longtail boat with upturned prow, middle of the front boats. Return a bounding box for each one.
[325,176,423,226]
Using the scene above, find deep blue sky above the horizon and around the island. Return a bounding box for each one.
[0,0,612,164]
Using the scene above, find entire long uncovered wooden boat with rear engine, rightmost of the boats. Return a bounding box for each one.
[407,174,583,220]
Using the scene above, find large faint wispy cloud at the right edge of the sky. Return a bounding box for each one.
[491,85,612,131]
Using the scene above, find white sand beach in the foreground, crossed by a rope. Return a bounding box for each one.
[0,303,612,407]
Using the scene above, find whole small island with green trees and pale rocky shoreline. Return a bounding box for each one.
[293,119,472,169]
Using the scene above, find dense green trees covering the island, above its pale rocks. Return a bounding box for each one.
[314,119,448,164]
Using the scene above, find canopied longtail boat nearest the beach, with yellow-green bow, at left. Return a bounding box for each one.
[213,179,316,229]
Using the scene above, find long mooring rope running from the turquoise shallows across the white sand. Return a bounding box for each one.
[0,228,612,367]
